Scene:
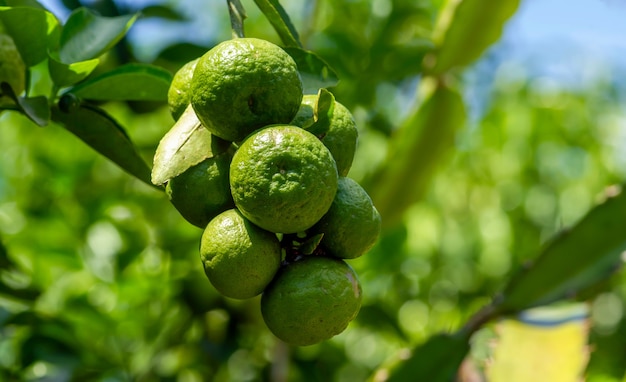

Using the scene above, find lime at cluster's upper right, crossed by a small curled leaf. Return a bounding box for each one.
[291,94,358,176]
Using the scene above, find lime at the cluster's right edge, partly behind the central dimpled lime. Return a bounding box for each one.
[309,177,381,259]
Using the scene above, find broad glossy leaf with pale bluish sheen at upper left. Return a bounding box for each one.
[59,8,137,64]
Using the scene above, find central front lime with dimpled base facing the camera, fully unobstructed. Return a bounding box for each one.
[230,125,337,233]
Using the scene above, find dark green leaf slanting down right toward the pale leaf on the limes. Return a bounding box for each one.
[52,100,152,185]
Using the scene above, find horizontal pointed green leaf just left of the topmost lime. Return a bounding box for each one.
[70,64,172,101]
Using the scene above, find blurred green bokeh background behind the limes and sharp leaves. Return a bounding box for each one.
[0,0,626,382]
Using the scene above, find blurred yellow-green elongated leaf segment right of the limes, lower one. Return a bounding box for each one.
[364,80,465,227]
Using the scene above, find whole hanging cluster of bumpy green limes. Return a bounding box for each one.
[166,38,380,345]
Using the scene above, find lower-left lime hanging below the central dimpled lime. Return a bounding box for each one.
[200,209,281,299]
